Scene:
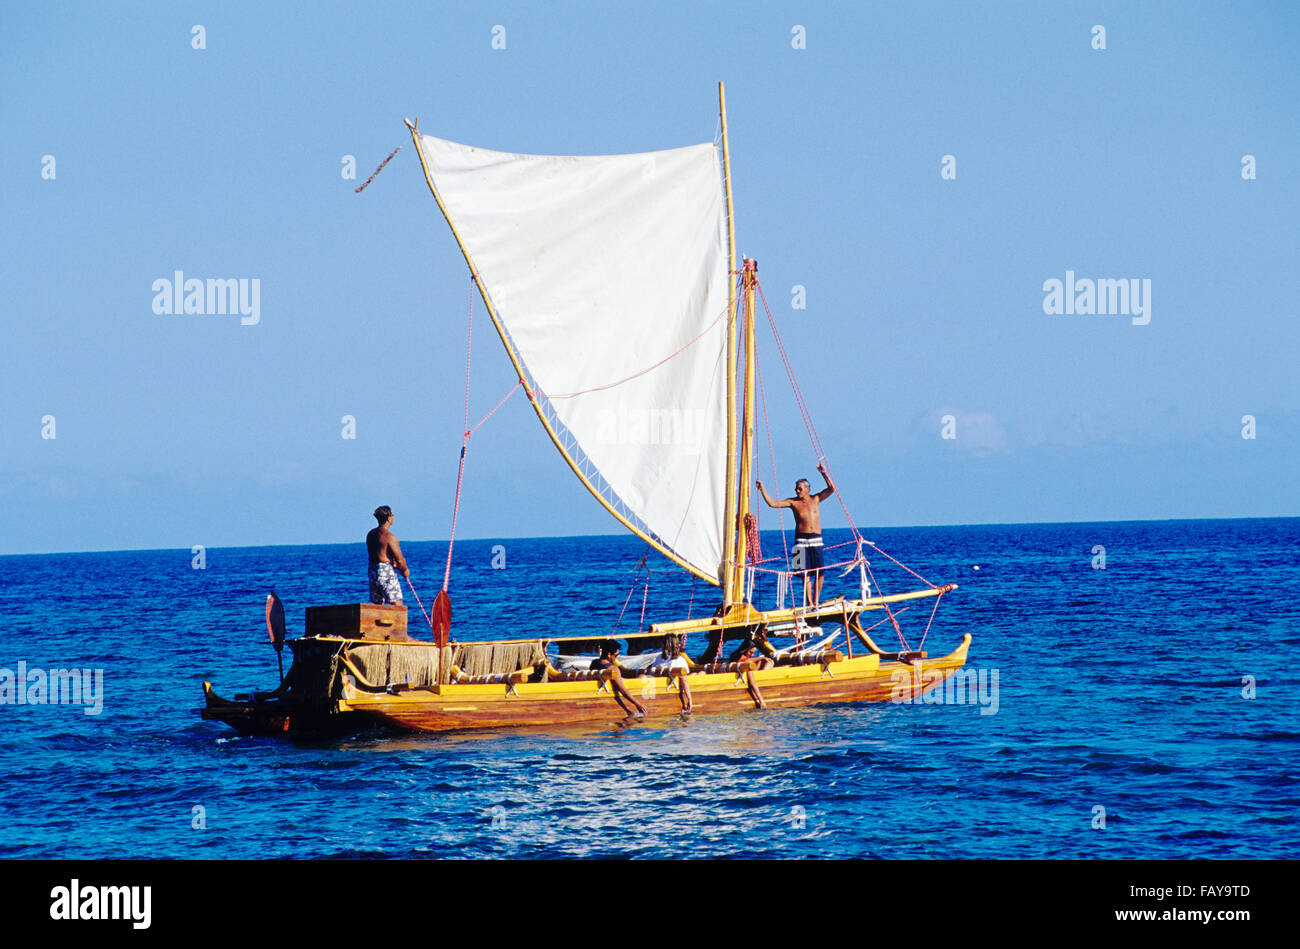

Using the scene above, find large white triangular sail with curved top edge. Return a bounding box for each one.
[419,135,729,579]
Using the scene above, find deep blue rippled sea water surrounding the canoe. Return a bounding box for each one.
[0,519,1300,858]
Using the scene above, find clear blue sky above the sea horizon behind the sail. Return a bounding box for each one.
[0,0,1300,554]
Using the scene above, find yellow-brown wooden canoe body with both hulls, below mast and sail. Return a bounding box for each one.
[203,585,970,735]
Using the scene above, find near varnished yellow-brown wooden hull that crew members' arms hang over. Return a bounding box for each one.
[338,634,971,732]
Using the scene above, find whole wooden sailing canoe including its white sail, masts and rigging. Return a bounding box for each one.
[202,83,971,735]
